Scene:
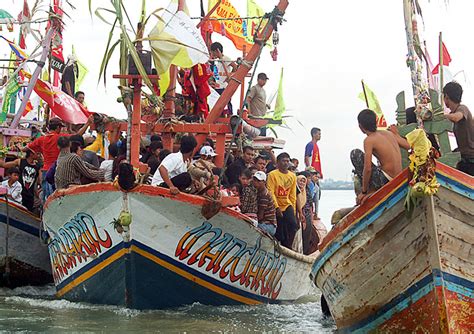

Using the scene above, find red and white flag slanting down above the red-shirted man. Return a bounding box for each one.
[35,79,91,124]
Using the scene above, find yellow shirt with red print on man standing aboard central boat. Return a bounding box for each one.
[267,169,296,212]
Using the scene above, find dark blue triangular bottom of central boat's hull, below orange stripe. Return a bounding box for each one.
[64,244,246,310]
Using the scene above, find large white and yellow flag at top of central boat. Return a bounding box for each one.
[148,1,209,95]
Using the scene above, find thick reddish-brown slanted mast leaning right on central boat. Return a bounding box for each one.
[196,0,289,151]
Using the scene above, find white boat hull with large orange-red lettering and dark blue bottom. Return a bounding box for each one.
[43,183,315,309]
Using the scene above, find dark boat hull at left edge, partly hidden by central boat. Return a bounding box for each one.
[0,198,53,288]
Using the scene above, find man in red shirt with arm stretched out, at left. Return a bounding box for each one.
[24,116,93,202]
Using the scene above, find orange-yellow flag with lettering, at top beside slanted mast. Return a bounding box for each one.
[208,0,252,51]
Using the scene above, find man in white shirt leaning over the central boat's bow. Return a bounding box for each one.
[151,136,197,195]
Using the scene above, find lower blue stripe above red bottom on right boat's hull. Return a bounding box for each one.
[341,269,474,333]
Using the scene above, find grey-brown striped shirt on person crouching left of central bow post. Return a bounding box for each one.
[54,152,104,189]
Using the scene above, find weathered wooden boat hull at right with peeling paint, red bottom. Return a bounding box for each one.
[311,163,474,333]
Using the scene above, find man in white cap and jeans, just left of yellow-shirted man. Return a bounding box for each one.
[252,171,276,236]
